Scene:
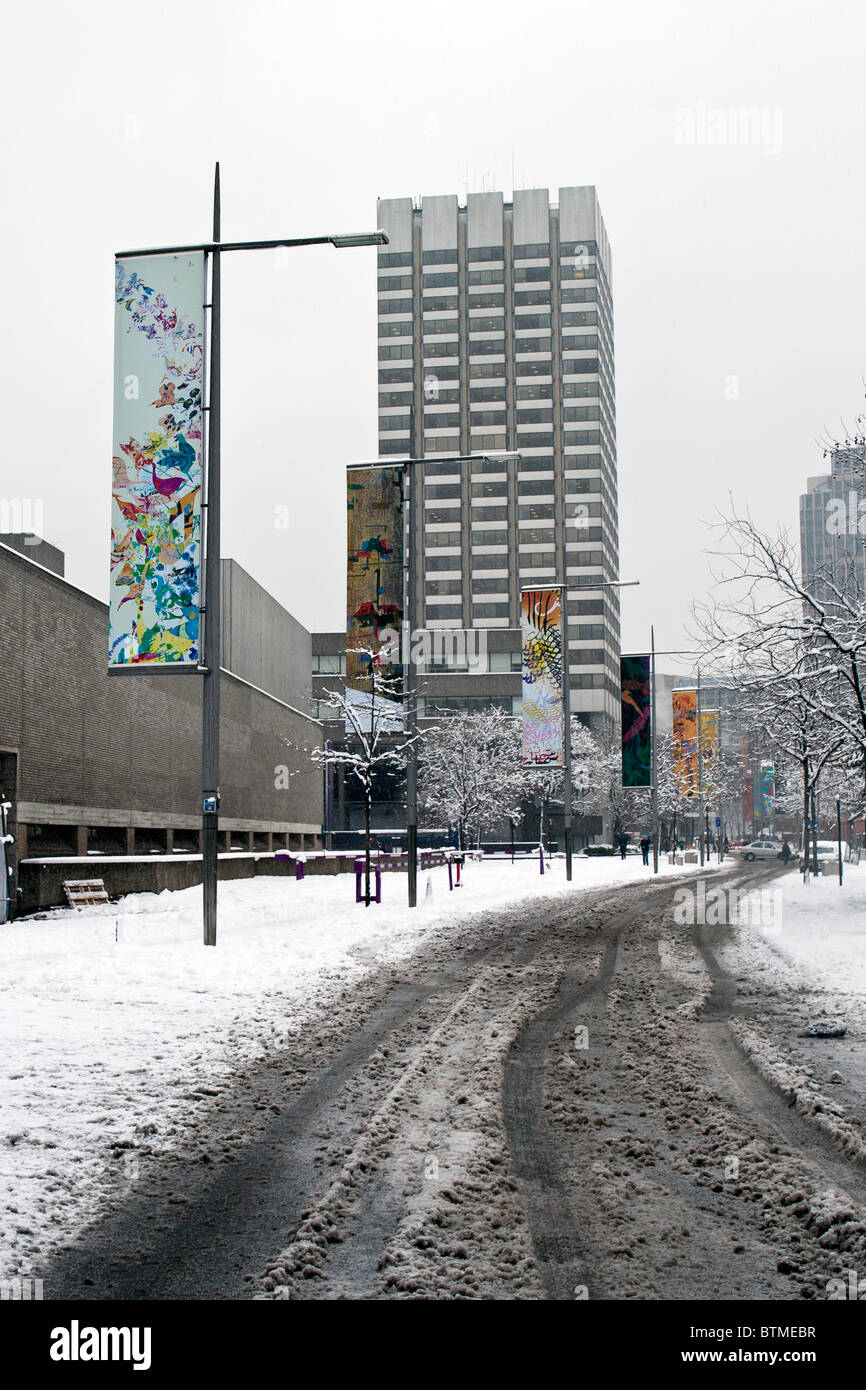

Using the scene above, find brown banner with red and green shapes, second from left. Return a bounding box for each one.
[346,464,403,689]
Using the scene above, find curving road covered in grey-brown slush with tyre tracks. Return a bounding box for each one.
[30,866,866,1300]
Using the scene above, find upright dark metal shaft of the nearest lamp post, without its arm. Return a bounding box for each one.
[202,163,221,947]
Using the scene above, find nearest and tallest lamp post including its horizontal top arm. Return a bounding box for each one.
[115,161,388,947]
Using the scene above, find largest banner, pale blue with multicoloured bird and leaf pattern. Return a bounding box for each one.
[108,252,204,670]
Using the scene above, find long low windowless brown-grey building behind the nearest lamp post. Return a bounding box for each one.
[0,537,322,904]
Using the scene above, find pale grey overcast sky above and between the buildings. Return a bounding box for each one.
[0,0,866,667]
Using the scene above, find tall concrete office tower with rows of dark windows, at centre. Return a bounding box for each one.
[378,188,620,723]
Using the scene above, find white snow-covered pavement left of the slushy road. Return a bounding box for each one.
[0,856,711,1272]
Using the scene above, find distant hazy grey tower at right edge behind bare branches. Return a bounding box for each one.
[799,445,866,602]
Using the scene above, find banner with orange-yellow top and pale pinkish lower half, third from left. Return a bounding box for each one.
[520,585,564,767]
